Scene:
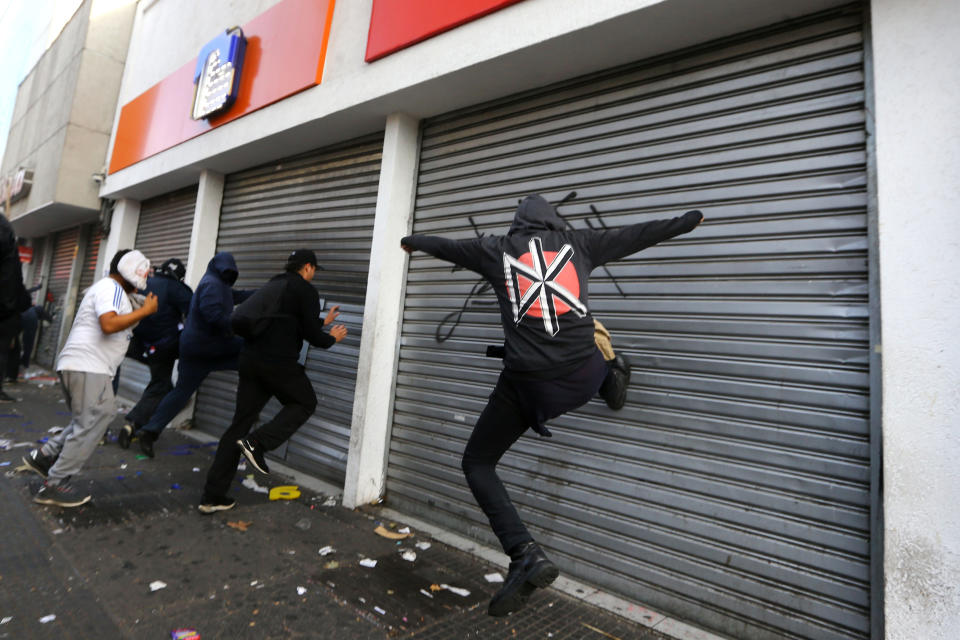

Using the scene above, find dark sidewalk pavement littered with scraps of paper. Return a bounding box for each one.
[0,378,680,640]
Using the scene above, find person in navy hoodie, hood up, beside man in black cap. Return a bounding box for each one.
[135,251,253,458]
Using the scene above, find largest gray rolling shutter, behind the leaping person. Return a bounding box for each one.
[388,8,871,640]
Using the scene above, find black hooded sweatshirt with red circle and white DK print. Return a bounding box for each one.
[401,195,703,379]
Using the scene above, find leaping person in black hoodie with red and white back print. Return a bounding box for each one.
[400,195,703,616]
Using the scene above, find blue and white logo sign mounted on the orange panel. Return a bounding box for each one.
[190,27,247,120]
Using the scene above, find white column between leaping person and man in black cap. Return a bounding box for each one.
[343,113,420,508]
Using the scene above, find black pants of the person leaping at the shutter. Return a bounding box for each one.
[461,351,607,555]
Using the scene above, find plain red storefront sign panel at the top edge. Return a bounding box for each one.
[365,0,521,62]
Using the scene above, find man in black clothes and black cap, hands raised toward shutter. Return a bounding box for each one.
[198,249,347,514]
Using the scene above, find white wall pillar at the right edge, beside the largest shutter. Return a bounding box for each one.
[870,0,960,640]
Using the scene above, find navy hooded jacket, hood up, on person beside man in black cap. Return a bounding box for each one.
[180,251,252,360]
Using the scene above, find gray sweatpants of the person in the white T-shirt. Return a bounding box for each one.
[40,371,116,484]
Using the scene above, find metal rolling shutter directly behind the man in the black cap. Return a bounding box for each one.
[195,134,383,483]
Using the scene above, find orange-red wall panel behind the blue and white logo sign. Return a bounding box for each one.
[110,0,335,173]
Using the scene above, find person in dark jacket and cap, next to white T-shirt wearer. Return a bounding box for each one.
[117,258,193,449]
